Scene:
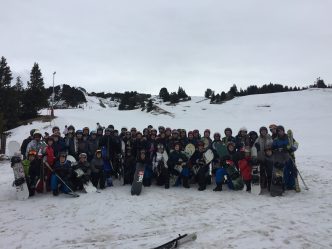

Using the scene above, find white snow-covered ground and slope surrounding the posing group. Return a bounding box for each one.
[0,89,332,249]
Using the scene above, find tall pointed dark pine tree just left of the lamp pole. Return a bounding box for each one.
[22,63,48,118]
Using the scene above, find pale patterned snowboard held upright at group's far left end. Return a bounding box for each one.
[8,141,29,201]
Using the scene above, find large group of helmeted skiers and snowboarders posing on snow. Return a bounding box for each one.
[17,123,298,196]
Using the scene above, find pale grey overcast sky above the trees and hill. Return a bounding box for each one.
[0,0,332,95]
